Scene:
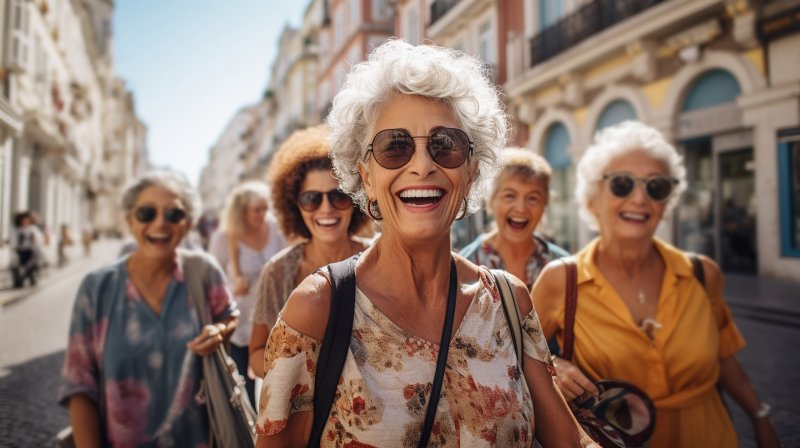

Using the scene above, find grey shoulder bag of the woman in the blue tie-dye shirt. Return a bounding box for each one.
[182,252,257,448]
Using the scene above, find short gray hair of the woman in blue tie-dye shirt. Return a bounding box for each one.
[121,169,201,224]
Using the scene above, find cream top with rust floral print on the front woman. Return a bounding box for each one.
[256,269,549,447]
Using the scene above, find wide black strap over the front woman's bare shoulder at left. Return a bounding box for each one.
[308,257,356,447]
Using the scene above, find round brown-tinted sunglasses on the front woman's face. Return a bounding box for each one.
[367,127,473,170]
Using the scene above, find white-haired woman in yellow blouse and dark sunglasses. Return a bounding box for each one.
[532,122,780,448]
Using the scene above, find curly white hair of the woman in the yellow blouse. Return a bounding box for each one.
[575,121,686,230]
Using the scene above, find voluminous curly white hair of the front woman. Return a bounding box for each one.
[326,39,508,213]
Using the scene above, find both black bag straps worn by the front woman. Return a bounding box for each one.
[308,254,458,448]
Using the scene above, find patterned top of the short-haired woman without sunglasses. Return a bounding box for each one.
[458,233,569,290]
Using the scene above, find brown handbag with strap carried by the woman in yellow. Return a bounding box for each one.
[561,257,656,448]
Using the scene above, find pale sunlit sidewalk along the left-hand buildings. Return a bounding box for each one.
[0,239,122,310]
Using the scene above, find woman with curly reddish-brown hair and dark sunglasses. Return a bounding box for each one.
[250,126,368,377]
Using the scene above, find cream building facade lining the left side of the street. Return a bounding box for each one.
[0,0,146,266]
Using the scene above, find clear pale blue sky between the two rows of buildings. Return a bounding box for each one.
[114,0,308,185]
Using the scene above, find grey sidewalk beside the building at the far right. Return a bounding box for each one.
[725,274,800,328]
